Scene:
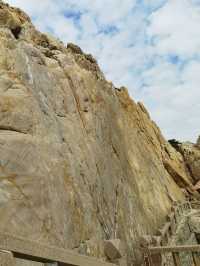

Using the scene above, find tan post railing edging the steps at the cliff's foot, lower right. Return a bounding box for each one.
[141,201,200,266]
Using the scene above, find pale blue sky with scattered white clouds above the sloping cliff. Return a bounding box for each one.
[6,0,200,141]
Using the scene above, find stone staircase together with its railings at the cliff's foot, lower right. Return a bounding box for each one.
[141,201,200,266]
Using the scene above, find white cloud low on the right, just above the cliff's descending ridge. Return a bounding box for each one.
[140,60,200,140]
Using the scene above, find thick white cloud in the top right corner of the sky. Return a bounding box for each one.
[148,0,200,57]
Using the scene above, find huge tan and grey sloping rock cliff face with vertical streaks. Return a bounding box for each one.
[0,2,199,265]
